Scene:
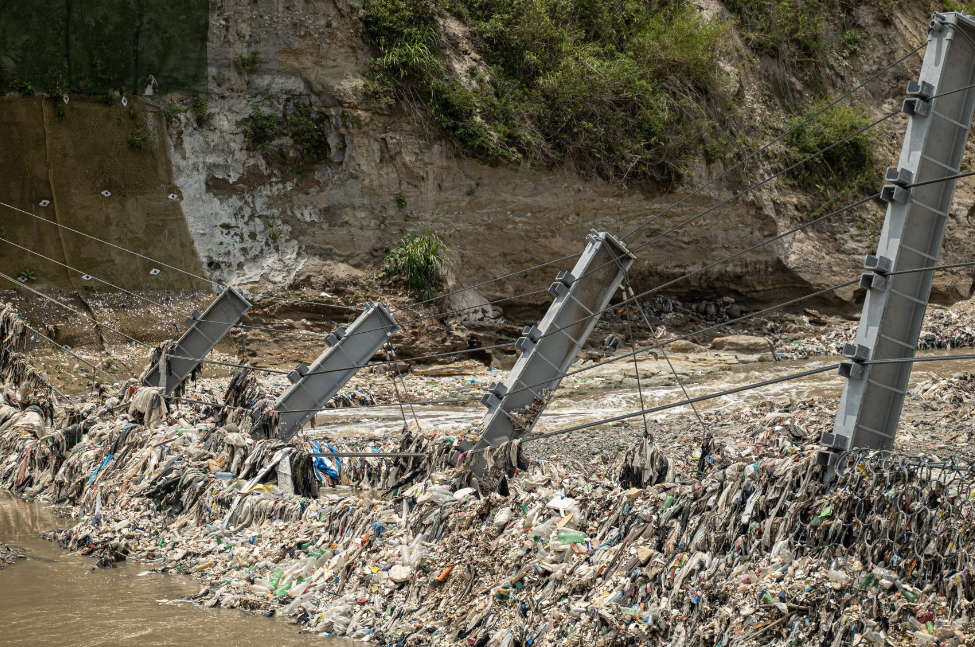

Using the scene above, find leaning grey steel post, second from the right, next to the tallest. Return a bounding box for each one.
[473,231,636,472]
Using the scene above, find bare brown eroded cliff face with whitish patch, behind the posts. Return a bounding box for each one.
[166,0,975,314]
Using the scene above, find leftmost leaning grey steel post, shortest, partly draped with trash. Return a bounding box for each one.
[142,287,251,395]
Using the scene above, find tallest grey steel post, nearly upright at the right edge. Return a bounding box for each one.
[818,13,975,469]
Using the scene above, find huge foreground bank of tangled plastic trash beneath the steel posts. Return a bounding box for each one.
[0,300,975,647]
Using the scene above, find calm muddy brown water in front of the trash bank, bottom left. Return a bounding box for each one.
[0,491,356,647]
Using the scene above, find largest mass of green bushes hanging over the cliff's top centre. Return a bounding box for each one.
[365,0,730,182]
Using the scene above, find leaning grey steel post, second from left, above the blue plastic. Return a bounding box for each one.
[274,303,399,441]
